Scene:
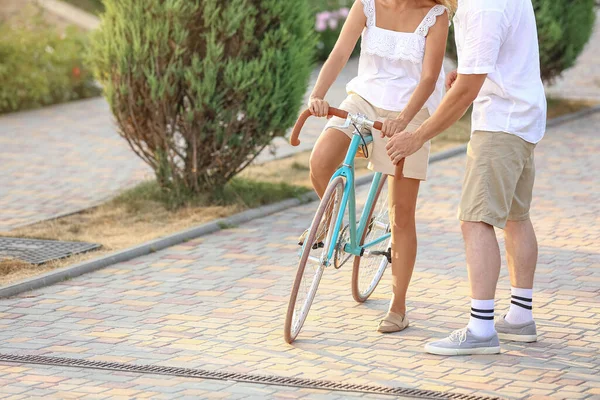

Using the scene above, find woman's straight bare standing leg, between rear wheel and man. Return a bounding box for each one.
[388,176,421,315]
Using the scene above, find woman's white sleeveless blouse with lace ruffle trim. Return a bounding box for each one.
[346,0,448,114]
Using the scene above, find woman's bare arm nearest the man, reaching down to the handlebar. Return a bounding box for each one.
[382,12,449,137]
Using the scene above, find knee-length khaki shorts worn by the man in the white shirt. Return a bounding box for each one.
[458,131,535,229]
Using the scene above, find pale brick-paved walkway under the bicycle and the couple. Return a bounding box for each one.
[0,114,600,399]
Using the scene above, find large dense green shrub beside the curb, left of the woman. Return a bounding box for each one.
[89,0,315,194]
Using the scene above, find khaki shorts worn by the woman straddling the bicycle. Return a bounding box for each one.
[325,93,431,181]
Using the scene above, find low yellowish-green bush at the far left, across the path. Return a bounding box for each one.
[0,24,99,113]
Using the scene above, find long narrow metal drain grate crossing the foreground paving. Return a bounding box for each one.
[0,353,499,400]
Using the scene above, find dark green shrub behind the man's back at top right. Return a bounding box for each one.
[448,0,596,82]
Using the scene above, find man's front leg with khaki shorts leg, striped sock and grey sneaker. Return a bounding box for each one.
[425,132,528,355]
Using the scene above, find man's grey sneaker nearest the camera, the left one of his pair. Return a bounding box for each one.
[425,328,500,356]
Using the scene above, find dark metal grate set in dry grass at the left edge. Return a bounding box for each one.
[0,237,100,265]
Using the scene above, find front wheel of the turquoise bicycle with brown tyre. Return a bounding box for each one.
[283,177,344,343]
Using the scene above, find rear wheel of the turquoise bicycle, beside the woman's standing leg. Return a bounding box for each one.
[352,175,392,303]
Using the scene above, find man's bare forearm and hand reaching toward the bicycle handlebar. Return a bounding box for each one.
[387,74,487,165]
